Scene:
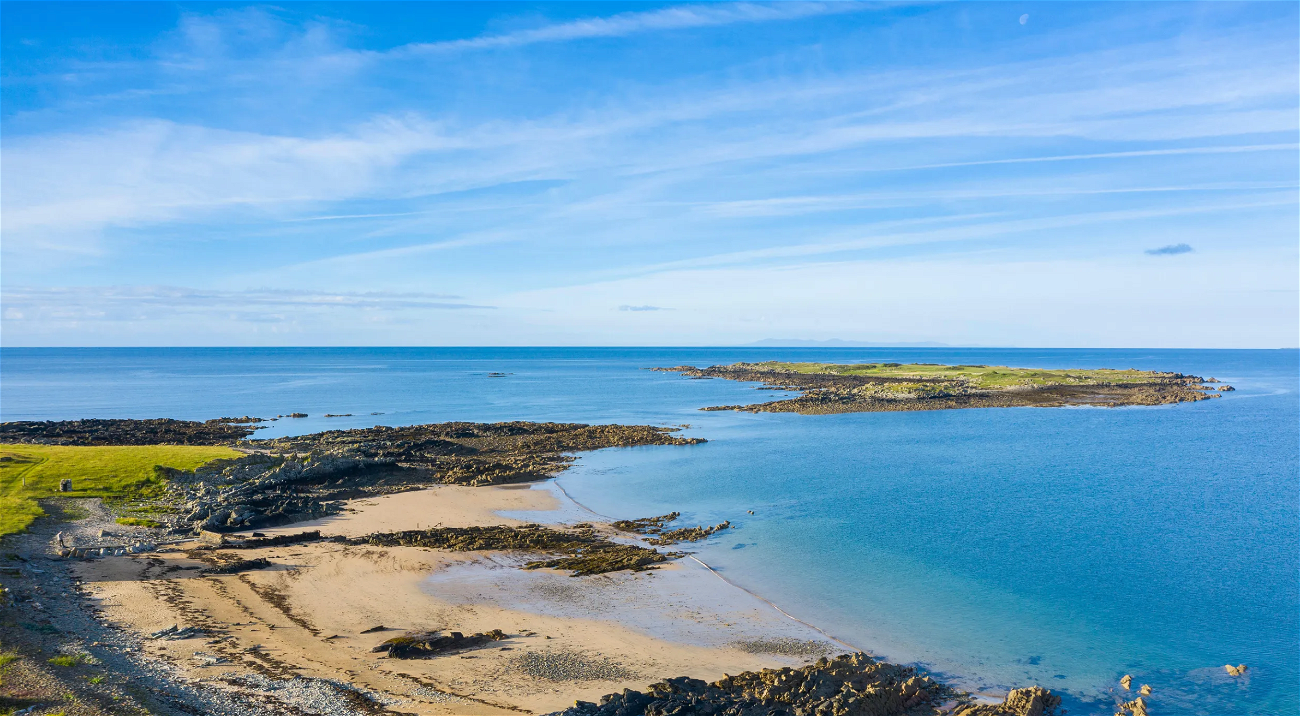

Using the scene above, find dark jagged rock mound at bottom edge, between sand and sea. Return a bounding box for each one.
[559,654,961,716]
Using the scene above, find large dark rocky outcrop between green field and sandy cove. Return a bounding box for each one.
[142,422,703,531]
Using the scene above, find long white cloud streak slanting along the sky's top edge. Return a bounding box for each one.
[394,1,872,53]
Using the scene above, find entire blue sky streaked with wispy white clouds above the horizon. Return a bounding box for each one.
[0,3,1300,347]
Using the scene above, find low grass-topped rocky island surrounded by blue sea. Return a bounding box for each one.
[651,361,1232,415]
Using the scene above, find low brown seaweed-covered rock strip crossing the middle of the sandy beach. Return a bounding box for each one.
[348,525,683,577]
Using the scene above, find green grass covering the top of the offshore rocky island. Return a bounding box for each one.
[751,361,1175,389]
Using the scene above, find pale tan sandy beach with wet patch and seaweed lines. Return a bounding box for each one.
[79,486,848,715]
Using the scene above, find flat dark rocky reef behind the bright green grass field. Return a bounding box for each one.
[0,417,260,444]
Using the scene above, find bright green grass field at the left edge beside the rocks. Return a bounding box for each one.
[0,444,241,537]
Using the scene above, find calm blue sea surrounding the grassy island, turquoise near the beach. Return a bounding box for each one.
[0,348,1300,716]
